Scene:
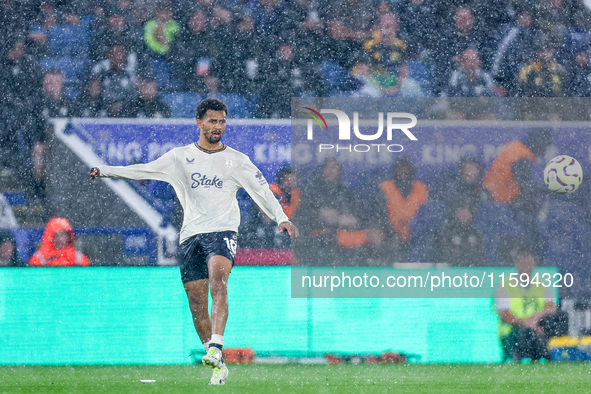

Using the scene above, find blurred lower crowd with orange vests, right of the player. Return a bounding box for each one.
[256,128,591,291]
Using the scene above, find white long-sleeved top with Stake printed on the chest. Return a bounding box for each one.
[99,143,289,243]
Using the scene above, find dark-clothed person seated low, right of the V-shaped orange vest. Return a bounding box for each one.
[433,196,486,267]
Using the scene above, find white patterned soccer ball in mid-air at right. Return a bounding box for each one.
[544,155,583,194]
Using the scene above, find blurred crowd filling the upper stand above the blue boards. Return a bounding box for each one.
[0,0,591,205]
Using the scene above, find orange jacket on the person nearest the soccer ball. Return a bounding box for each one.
[482,141,535,203]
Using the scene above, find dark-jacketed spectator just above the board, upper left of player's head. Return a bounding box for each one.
[123,77,171,118]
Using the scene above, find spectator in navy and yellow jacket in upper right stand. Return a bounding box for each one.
[517,37,566,97]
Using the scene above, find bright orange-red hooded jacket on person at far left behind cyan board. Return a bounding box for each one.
[29,218,90,267]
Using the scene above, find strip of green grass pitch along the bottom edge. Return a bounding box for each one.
[0,363,591,394]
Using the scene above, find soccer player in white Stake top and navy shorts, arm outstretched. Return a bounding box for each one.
[90,98,299,385]
